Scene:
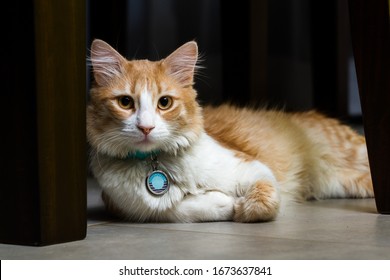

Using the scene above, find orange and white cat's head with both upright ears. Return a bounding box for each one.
[87,40,203,157]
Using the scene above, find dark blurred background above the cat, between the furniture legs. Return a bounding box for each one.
[87,0,361,120]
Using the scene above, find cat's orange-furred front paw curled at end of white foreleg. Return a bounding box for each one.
[233,182,280,223]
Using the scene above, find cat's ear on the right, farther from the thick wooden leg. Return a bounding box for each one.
[163,41,198,86]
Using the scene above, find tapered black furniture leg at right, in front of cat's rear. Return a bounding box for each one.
[349,0,390,214]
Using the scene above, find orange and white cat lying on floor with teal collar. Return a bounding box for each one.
[87,39,373,222]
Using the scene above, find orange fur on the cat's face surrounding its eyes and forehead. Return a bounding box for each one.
[87,52,203,156]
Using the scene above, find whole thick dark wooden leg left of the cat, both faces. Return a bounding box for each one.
[0,0,86,245]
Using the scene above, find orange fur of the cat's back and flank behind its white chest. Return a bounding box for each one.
[204,105,373,199]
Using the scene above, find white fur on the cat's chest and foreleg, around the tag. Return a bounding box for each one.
[92,130,276,221]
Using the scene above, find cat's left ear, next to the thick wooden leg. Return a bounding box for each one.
[90,39,126,86]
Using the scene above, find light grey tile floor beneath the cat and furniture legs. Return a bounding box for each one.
[0,179,390,260]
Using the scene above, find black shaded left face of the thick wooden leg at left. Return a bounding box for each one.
[0,0,39,244]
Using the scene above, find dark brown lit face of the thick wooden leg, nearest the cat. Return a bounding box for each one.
[35,0,86,243]
